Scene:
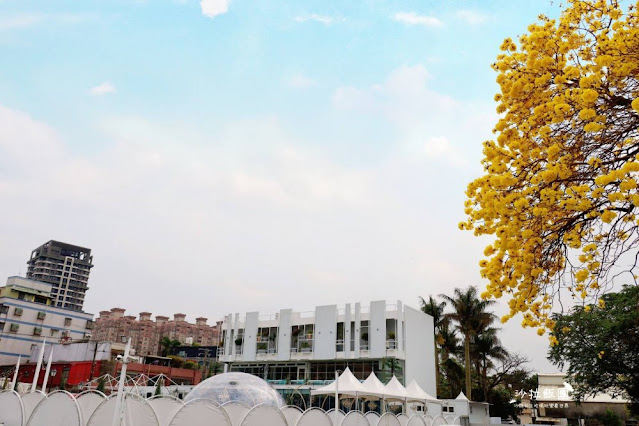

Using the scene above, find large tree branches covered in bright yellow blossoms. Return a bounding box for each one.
[460,0,639,339]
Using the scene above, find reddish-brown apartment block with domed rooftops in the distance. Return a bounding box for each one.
[92,308,221,356]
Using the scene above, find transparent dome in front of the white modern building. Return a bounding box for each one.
[185,373,284,407]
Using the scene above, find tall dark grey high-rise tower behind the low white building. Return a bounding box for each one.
[27,240,93,312]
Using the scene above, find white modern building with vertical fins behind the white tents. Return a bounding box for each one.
[218,300,436,395]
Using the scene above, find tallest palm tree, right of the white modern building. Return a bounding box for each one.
[440,286,495,399]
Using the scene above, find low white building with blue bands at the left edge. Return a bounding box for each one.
[0,277,93,365]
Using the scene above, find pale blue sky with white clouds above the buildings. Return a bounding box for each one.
[0,0,559,372]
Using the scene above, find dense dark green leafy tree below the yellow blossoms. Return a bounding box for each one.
[548,286,639,412]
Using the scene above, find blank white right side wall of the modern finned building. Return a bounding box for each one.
[404,306,437,396]
